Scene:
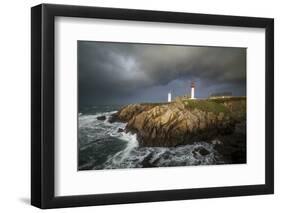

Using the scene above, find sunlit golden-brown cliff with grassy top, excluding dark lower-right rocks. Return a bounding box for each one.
[115,99,246,146]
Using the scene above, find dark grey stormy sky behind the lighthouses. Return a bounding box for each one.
[78,41,246,106]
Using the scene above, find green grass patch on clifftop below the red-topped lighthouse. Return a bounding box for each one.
[183,100,229,114]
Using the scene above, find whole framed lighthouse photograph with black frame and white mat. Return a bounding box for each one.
[31,4,274,208]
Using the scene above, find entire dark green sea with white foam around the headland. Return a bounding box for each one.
[78,106,222,170]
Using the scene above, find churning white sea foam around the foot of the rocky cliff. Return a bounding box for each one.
[79,111,222,169]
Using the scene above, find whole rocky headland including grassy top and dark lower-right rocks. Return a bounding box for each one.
[104,97,246,163]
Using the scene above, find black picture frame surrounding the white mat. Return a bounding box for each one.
[31,4,274,209]
